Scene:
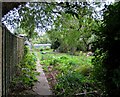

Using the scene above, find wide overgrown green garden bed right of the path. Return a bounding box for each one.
[35,48,100,97]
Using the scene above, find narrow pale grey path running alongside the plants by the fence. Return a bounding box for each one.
[33,60,52,95]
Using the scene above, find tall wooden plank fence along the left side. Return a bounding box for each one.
[2,27,24,97]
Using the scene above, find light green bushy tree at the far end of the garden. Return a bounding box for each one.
[47,14,99,54]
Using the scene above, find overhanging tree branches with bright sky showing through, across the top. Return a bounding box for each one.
[3,2,101,43]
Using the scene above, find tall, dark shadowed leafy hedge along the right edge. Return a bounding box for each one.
[93,2,120,97]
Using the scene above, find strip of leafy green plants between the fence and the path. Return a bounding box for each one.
[11,46,39,95]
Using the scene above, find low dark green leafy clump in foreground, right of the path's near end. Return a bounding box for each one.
[54,72,93,96]
